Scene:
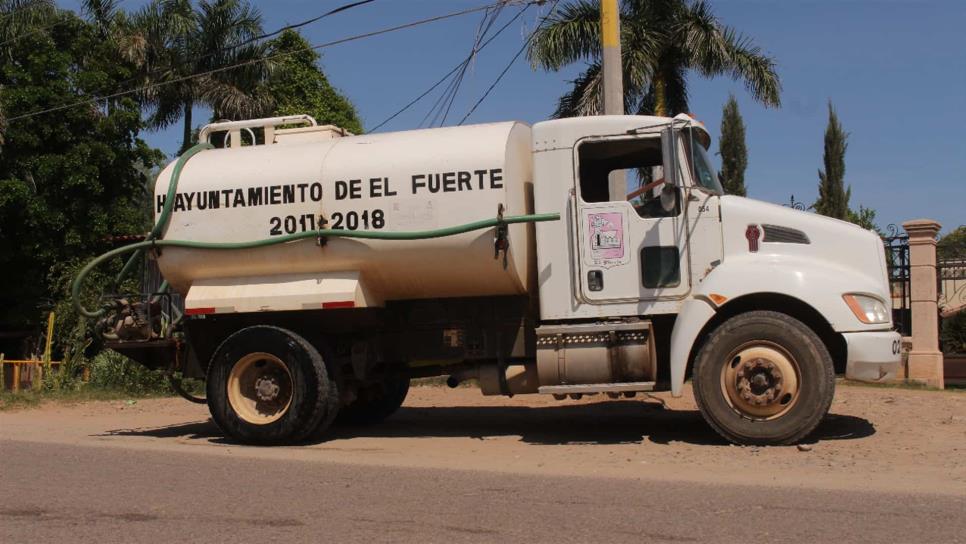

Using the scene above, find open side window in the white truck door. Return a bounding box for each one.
[577,137,681,217]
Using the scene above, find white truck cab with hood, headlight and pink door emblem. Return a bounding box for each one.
[533,115,901,439]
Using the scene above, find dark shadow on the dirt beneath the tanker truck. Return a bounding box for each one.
[100,401,875,446]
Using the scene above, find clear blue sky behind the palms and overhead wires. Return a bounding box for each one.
[61,0,966,231]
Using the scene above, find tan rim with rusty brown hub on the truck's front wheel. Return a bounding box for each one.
[721,342,801,420]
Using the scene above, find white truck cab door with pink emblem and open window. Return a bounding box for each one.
[574,129,690,304]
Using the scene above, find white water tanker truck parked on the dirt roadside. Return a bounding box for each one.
[75,115,901,444]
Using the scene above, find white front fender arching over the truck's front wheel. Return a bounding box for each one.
[671,253,891,397]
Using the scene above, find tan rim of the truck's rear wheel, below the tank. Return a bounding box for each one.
[228,352,292,425]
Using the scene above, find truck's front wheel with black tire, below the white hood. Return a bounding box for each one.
[692,311,835,445]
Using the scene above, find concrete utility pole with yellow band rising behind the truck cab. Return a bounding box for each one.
[600,0,627,200]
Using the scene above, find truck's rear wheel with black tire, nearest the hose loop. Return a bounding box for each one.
[207,325,339,445]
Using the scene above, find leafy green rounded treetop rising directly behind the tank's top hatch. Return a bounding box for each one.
[265,30,362,134]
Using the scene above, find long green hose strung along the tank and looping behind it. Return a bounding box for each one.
[70,144,560,319]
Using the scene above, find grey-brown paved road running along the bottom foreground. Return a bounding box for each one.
[0,440,966,544]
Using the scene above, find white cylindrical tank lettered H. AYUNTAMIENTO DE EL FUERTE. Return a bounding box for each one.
[154,122,535,300]
